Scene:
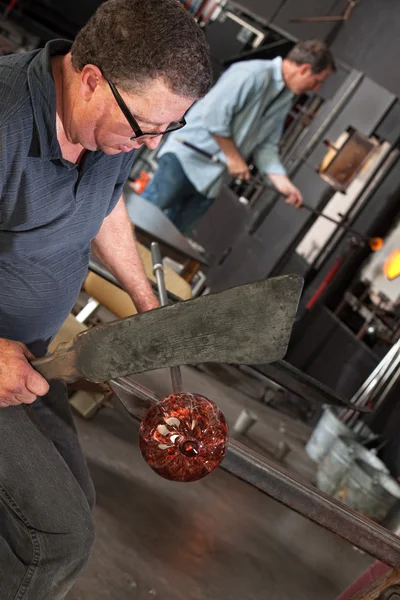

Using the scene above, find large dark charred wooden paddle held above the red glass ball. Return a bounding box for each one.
[32,275,303,382]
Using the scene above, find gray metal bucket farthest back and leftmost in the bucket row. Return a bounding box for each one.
[305,408,355,462]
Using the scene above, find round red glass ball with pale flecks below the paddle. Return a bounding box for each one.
[139,393,228,481]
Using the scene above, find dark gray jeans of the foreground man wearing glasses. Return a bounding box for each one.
[0,381,95,600]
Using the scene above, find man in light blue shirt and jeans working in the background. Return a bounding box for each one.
[142,40,335,234]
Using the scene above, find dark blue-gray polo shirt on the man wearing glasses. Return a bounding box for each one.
[0,40,133,356]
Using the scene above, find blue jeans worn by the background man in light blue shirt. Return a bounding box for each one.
[142,152,214,235]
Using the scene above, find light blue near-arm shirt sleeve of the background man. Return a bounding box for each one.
[201,65,265,137]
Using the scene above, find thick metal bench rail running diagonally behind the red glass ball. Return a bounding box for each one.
[110,378,400,568]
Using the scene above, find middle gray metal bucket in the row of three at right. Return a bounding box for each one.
[316,437,358,494]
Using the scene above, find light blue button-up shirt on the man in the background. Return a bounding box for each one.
[159,57,294,197]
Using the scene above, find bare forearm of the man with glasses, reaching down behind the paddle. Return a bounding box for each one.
[92,198,158,312]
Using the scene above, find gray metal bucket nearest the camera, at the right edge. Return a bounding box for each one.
[335,457,400,522]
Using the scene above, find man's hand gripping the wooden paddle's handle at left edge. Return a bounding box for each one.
[0,338,49,408]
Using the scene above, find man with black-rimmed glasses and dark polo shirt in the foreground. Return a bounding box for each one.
[0,0,211,600]
